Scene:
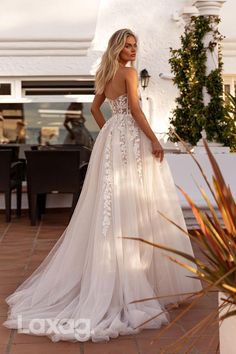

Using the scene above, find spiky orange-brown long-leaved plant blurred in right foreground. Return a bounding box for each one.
[125,136,236,353]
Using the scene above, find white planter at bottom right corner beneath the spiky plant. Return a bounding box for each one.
[218,292,236,354]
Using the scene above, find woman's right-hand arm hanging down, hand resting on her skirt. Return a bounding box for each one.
[125,67,164,161]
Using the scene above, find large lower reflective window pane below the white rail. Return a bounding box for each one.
[0,101,110,144]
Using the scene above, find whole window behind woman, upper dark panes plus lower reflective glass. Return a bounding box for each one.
[0,78,111,145]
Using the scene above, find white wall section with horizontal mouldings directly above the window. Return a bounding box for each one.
[0,0,100,73]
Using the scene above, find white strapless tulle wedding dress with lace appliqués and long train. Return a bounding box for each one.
[4,94,201,342]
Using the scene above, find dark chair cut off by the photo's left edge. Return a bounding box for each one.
[0,149,23,222]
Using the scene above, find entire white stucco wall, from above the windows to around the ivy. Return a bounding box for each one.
[0,0,236,132]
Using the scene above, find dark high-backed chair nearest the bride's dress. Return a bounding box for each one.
[25,150,81,225]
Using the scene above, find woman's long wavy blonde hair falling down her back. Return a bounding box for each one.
[95,28,137,94]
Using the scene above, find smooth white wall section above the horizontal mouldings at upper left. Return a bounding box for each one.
[0,0,99,41]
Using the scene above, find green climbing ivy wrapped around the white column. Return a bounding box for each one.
[169,16,232,145]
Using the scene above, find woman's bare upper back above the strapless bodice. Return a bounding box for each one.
[104,68,127,100]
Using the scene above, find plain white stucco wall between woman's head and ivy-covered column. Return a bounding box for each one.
[89,0,191,132]
